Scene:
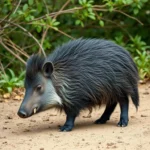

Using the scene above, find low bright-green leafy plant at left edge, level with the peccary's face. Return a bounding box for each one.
[0,69,25,92]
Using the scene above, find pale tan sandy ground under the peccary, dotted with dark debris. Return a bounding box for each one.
[0,83,150,150]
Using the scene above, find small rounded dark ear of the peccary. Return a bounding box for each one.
[42,62,54,77]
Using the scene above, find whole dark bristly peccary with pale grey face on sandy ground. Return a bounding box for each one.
[18,39,139,131]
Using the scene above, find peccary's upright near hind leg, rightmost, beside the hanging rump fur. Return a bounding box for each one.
[118,96,129,127]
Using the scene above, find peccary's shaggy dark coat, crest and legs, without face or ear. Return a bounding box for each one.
[24,39,139,131]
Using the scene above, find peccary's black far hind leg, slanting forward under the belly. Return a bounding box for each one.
[95,102,117,124]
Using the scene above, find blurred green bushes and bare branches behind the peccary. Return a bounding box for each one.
[0,0,150,91]
